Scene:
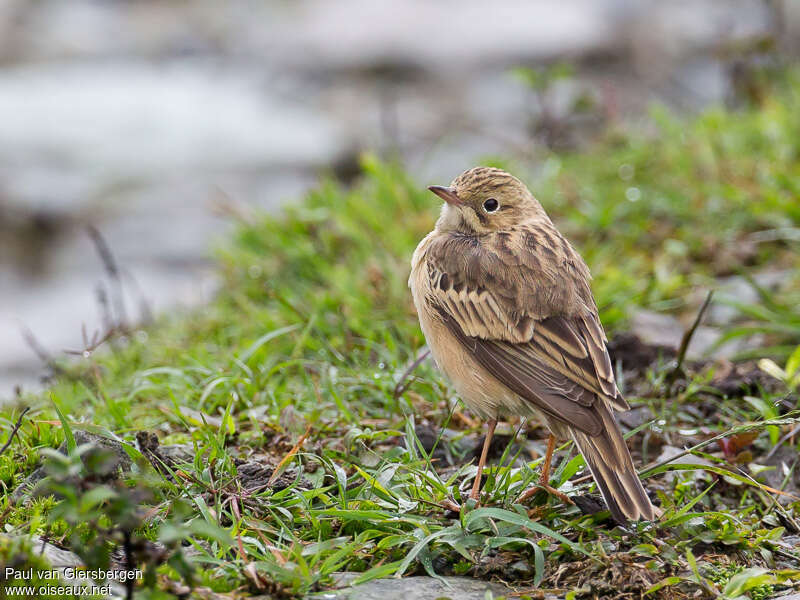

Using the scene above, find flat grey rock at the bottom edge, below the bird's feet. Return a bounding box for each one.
[308,577,511,600]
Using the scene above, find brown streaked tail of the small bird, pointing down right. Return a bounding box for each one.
[571,402,661,523]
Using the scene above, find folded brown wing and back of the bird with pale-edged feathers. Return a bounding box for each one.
[427,228,627,435]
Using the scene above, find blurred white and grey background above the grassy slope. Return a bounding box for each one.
[0,0,800,397]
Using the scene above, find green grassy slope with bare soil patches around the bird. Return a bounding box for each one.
[0,68,800,598]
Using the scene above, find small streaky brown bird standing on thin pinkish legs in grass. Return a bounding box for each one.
[408,167,661,523]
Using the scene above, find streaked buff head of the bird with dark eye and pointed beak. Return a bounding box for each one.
[428,167,547,234]
